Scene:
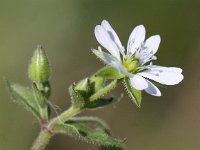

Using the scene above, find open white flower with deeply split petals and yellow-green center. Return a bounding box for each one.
[95,20,183,96]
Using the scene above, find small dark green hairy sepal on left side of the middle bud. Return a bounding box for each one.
[69,84,85,108]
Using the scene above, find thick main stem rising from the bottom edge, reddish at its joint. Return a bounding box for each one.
[31,106,81,150]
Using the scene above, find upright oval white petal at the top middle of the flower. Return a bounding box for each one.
[127,25,146,57]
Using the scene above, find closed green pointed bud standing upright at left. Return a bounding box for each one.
[28,45,50,82]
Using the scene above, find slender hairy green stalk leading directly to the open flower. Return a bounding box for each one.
[89,79,122,102]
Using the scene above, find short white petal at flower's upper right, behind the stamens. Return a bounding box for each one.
[144,35,161,55]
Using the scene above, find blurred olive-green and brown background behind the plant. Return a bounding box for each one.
[0,0,200,150]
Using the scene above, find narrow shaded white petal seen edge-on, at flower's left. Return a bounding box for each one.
[98,47,127,74]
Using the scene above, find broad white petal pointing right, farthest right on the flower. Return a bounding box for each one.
[138,66,183,85]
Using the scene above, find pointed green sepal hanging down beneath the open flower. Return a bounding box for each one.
[125,78,142,107]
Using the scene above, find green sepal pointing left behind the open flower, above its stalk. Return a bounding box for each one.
[95,66,125,79]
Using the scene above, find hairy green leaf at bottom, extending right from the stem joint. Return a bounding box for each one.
[54,121,123,147]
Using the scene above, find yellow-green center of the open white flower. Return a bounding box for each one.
[122,57,140,73]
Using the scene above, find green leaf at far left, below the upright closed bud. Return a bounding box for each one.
[6,81,41,120]
